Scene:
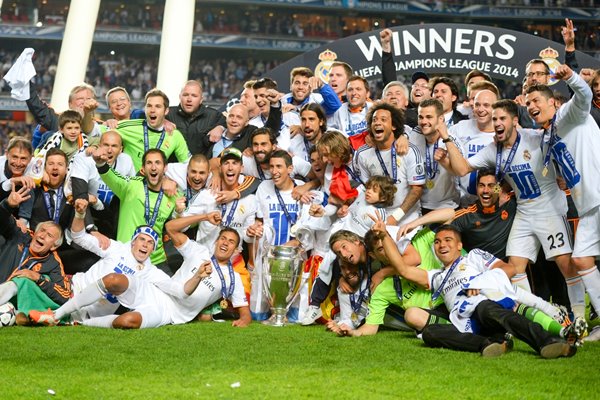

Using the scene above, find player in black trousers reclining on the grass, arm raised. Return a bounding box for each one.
[373,221,577,358]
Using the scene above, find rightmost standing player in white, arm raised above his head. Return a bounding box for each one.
[526,65,600,328]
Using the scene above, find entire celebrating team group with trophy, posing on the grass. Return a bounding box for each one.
[0,20,600,358]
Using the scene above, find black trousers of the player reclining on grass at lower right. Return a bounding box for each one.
[423,300,552,353]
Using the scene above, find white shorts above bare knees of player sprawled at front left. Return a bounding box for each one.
[117,275,172,329]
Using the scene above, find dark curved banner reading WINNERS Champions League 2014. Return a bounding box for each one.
[267,24,600,86]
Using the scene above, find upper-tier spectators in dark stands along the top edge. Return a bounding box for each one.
[2,0,600,51]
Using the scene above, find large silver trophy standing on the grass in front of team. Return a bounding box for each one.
[262,246,303,326]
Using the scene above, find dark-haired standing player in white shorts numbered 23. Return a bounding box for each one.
[443,100,575,301]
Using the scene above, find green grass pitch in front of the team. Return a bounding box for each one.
[0,322,600,400]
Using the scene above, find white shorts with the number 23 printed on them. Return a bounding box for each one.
[506,212,573,262]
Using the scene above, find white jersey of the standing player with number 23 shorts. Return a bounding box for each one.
[467,129,567,215]
